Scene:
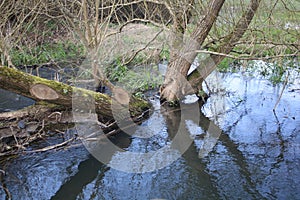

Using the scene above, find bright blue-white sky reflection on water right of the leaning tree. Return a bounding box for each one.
[203,71,300,199]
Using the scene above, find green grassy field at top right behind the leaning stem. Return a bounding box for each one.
[204,0,300,58]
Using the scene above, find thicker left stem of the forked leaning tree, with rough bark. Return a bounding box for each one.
[160,0,225,102]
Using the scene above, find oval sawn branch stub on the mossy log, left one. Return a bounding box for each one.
[30,84,59,100]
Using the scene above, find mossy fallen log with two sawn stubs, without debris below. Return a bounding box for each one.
[0,66,150,119]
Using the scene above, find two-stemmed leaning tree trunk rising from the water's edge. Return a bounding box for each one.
[161,0,261,102]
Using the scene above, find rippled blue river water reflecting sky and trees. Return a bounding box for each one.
[0,68,300,200]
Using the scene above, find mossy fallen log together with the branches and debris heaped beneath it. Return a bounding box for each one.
[0,66,151,156]
